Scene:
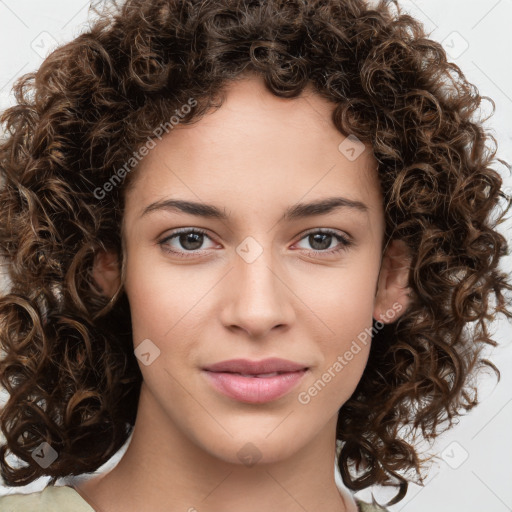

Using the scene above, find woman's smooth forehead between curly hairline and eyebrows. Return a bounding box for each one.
[122,76,381,226]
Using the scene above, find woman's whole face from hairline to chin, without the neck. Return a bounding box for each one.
[113,78,408,463]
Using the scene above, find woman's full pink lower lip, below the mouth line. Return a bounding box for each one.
[205,370,307,404]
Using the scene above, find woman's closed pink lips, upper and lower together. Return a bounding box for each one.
[204,358,308,403]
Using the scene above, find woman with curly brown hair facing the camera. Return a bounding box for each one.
[0,0,512,512]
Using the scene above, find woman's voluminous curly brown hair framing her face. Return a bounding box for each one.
[0,0,512,501]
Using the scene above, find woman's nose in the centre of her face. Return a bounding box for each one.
[221,243,295,339]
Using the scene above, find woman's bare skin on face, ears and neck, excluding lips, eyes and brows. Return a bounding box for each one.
[84,76,409,512]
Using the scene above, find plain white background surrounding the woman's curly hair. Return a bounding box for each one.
[0,0,512,512]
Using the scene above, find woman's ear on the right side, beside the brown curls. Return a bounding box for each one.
[373,240,411,324]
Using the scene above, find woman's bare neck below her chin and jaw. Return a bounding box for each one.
[77,384,352,512]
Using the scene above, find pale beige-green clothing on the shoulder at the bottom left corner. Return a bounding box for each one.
[0,485,94,512]
